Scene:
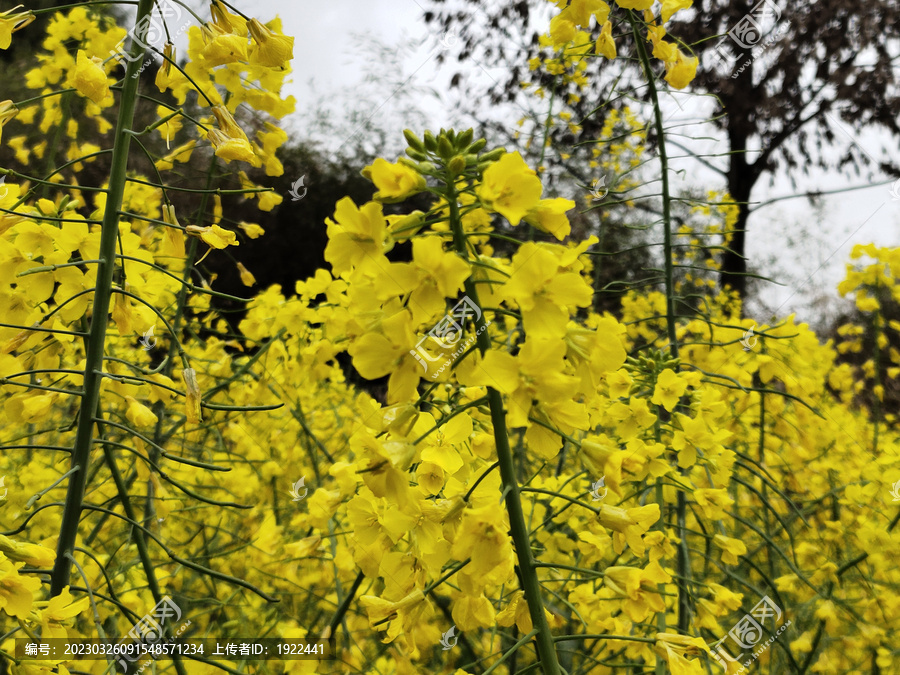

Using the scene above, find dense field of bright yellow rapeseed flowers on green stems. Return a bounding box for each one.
[0,0,900,675]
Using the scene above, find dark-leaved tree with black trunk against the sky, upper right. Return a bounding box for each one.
[425,0,900,297]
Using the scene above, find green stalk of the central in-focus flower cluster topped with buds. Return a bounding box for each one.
[447,172,562,675]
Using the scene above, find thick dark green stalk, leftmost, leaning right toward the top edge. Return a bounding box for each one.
[50,0,153,596]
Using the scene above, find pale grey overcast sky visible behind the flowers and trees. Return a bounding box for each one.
[240,0,900,323]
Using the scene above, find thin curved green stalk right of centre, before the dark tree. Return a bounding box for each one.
[628,10,691,634]
